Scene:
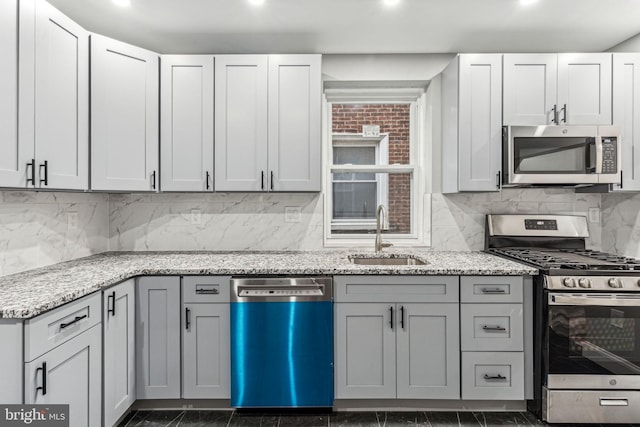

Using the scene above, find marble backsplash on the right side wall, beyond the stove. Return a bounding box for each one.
[602,193,640,258]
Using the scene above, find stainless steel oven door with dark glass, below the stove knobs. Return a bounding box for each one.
[544,292,640,389]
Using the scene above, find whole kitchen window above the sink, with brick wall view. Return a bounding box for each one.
[325,90,428,247]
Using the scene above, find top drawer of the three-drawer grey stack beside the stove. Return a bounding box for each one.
[460,276,524,302]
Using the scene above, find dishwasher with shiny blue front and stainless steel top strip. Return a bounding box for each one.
[231,277,333,408]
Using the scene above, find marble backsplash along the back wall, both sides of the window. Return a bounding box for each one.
[109,189,601,251]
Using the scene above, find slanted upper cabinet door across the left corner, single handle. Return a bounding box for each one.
[91,35,159,191]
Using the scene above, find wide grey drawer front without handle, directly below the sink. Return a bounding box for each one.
[333,276,459,302]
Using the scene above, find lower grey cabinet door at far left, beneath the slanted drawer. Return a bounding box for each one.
[24,326,102,427]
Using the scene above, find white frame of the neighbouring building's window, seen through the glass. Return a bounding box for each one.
[329,133,389,230]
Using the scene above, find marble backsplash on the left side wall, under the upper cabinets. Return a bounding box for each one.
[0,191,109,276]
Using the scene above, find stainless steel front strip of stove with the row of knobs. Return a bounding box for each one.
[544,276,640,292]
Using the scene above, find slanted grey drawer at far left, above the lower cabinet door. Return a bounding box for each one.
[24,292,102,362]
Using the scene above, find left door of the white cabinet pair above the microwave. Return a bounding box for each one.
[502,53,558,126]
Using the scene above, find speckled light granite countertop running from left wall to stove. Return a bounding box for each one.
[0,249,538,319]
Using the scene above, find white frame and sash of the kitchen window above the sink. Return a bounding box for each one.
[323,88,431,250]
